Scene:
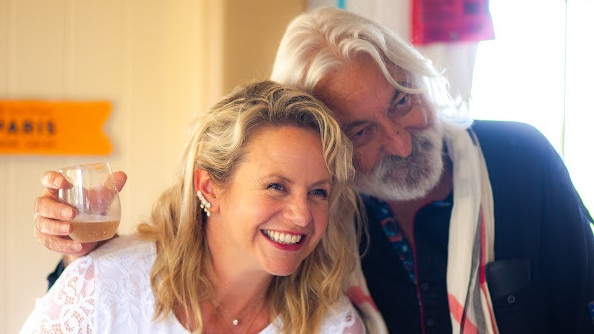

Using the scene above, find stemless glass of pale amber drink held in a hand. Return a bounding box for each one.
[58,163,120,242]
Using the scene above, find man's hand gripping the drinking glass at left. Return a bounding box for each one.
[33,171,127,265]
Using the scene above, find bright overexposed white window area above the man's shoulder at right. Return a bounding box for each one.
[471,0,594,213]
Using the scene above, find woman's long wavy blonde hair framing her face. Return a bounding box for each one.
[138,81,360,333]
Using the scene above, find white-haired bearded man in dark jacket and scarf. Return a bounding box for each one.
[271,8,594,333]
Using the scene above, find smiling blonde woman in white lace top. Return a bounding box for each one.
[22,82,365,333]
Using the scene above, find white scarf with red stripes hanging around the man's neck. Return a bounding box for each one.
[347,122,499,334]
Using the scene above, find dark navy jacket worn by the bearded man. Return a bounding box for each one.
[362,121,594,334]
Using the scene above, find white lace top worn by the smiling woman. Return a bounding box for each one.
[21,236,365,334]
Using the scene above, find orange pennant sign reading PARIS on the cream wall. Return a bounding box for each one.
[0,100,111,155]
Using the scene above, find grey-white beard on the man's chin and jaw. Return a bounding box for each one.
[355,124,443,201]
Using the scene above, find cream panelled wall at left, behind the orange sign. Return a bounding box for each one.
[0,0,223,333]
